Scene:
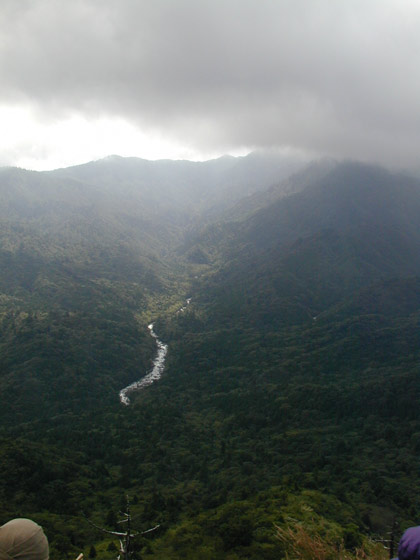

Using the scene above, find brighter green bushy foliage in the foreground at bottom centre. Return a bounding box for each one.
[140,488,374,560]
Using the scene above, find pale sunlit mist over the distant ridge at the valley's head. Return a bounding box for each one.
[49,151,307,225]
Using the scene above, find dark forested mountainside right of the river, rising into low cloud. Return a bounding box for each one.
[152,159,420,544]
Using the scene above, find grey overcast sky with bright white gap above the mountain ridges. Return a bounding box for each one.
[0,0,420,169]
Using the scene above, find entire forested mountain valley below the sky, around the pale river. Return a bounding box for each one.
[0,154,420,559]
